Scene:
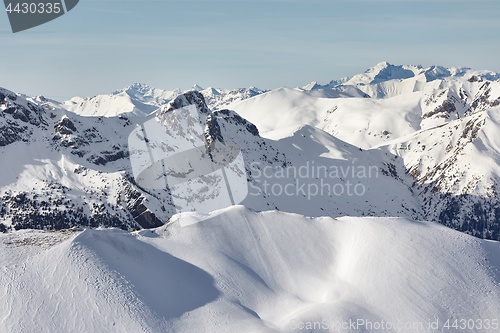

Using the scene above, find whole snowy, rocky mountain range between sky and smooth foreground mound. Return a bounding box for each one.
[0,63,500,239]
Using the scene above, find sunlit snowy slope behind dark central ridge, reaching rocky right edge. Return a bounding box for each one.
[228,72,500,149]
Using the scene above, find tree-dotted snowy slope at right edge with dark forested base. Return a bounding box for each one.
[379,107,500,238]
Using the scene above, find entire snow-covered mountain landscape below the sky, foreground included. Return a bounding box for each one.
[0,62,500,333]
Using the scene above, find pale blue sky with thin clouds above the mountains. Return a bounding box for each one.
[0,0,500,100]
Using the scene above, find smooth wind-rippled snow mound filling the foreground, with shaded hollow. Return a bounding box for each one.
[0,207,500,332]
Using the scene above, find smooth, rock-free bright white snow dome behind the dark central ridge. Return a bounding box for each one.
[228,88,422,149]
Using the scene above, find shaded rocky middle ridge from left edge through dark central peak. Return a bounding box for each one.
[0,90,422,233]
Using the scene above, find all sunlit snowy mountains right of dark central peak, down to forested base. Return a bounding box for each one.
[228,63,500,239]
